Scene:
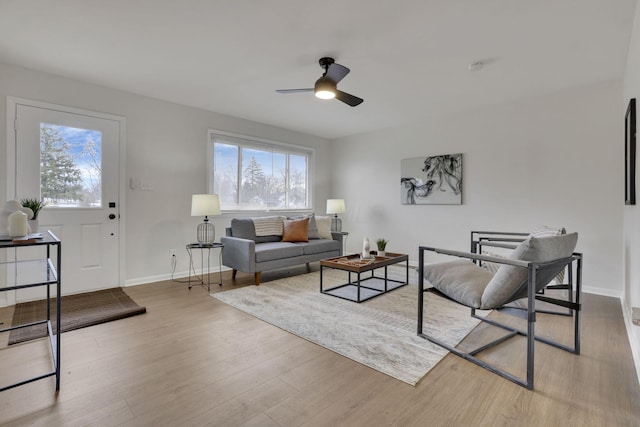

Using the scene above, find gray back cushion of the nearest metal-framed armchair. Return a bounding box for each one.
[479,233,578,309]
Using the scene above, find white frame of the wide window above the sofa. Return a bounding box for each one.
[207,129,316,214]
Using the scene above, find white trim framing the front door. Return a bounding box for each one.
[5,96,127,290]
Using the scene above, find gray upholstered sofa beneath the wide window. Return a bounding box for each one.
[220,218,343,285]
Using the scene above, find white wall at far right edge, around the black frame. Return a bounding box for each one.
[620,0,640,378]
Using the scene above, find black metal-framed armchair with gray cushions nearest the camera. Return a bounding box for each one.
[417,232,582,390]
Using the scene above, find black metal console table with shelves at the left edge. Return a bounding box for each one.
[0,231,62,391]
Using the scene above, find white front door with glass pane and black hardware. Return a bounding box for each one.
[8,102,121,301]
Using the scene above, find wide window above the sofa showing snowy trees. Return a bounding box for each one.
[209,131,313,211]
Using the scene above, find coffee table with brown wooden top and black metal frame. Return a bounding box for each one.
[320,252,409,303]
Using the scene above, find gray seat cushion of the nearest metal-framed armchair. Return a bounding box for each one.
[424,259,493,308]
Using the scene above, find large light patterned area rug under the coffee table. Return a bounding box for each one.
[211,267,486,385]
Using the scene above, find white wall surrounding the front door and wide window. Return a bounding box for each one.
[0,64,330,284]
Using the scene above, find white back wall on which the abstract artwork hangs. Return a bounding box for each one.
[331,82,624,297]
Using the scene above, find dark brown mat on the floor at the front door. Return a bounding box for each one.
[9,288,147,345]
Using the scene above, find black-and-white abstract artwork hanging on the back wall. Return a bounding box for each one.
[400,153,462,205]
